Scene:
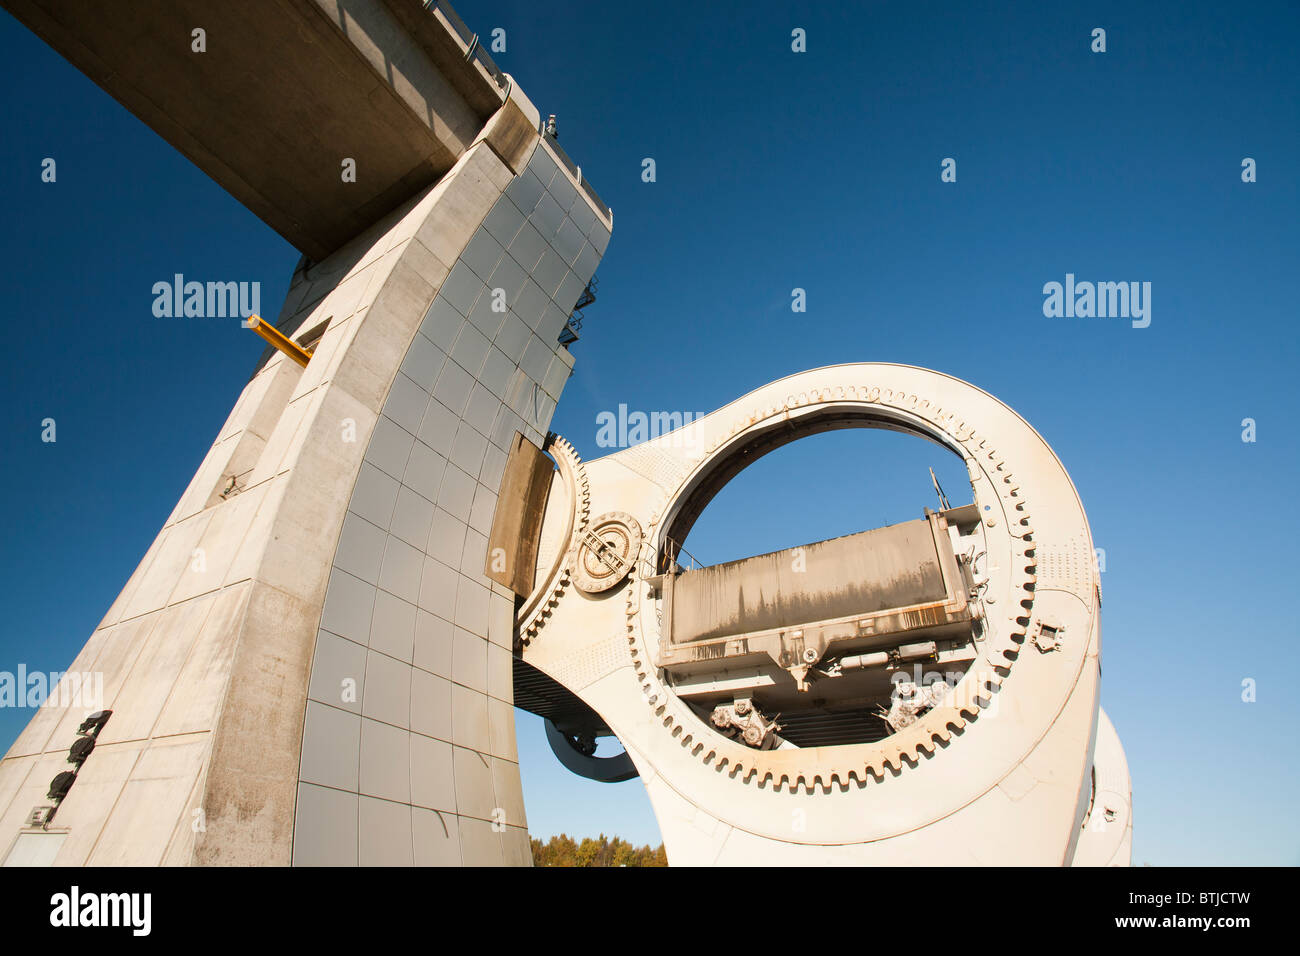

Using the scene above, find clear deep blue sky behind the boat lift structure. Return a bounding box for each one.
[0,0,1300,865]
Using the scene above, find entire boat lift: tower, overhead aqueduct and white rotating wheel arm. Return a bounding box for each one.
[0,0,1131,866]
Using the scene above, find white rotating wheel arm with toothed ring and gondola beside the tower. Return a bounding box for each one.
[488,364,1132,865]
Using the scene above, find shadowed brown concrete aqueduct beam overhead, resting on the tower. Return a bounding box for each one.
[3,0,512,261]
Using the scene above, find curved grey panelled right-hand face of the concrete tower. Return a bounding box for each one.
[293,142,605,866]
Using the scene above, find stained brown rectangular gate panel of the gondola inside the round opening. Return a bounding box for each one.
[672,519,946,644]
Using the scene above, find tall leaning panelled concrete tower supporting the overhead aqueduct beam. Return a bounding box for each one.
[0,113,611,865]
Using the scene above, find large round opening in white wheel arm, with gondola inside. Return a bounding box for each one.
[660,424,983,749]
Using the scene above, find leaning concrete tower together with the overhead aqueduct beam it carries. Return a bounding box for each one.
[0,0,612,865]
